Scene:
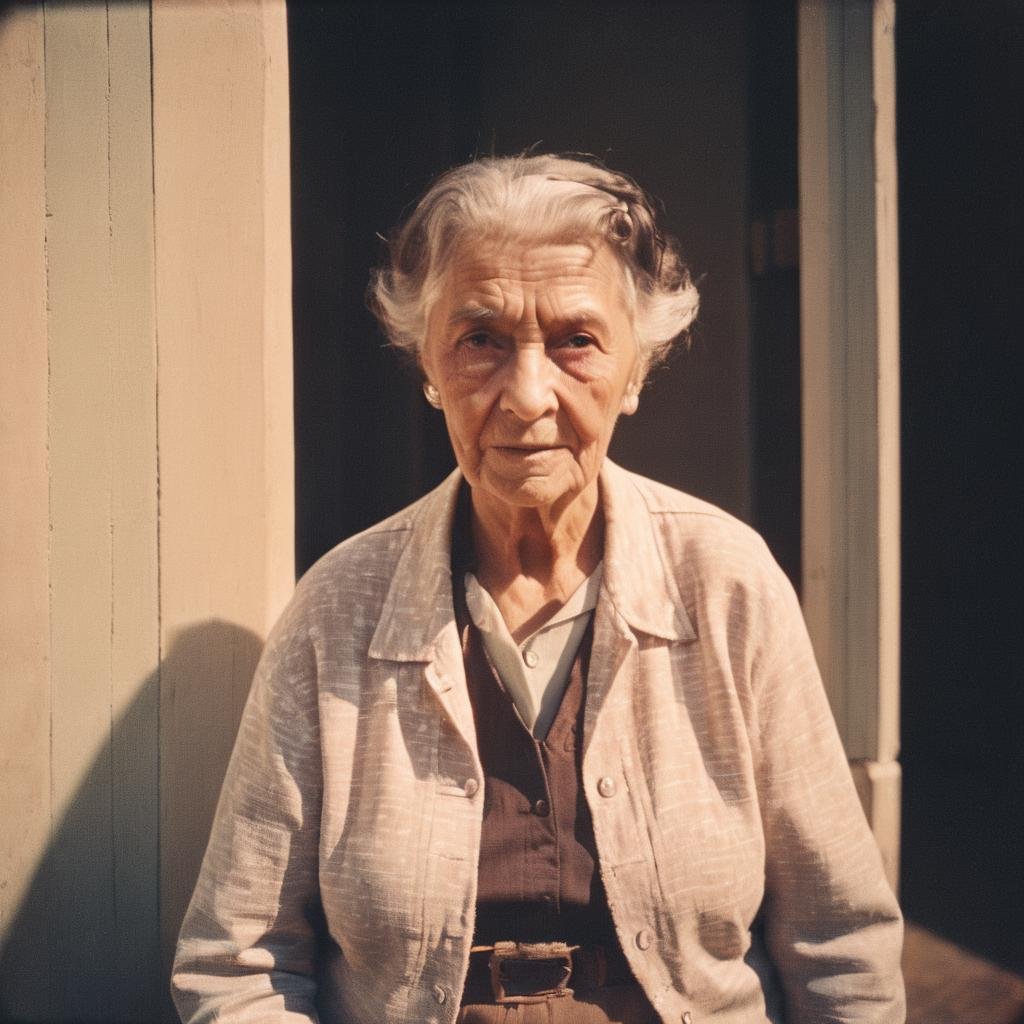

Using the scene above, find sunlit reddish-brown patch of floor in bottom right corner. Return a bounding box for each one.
[903,923,1024,1024]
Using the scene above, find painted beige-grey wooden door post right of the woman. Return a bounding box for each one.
[798,0,900,885]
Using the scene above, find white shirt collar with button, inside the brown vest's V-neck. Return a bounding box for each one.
[465,563,603,739]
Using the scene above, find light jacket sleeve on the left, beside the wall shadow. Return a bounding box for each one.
[171,602,322,1024]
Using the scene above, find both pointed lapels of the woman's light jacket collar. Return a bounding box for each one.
[370,459,696,662]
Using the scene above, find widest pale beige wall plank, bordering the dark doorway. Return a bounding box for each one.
[153,0,294,987]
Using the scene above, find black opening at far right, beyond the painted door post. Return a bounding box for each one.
[897,0,1024,973]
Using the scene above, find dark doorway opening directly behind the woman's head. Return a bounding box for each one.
[289,0,799,571]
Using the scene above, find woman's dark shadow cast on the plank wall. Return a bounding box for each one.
[0,622,262,1024]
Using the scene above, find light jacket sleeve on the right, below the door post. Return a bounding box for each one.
[753,563,905,1024]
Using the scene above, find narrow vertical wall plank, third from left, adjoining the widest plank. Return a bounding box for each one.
[108,0,161,1021]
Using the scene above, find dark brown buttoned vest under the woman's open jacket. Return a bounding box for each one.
[453,562,617,948]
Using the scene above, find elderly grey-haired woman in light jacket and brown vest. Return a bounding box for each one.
[173,157,903,1024]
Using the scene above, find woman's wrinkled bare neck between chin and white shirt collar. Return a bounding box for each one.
[472,480,604,641]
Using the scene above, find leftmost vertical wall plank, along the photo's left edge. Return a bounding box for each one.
[0,7,50,1018]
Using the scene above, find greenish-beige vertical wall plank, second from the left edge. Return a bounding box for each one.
[46,4,116,1020]
